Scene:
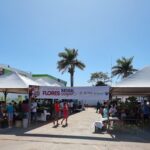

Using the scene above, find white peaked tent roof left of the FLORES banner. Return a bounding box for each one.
[0,72,39,93]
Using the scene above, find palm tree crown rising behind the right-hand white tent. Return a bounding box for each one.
[112,57,137,78]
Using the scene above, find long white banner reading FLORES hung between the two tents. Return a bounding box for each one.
[29,86,109,101]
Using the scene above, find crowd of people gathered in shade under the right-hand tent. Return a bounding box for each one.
[96,101,150,123]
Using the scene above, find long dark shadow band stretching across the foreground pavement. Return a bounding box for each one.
[0,123,150,143]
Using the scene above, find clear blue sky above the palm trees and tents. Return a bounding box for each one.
[0,0,150,86]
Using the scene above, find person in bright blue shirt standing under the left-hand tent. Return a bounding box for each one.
[6,103,14,128]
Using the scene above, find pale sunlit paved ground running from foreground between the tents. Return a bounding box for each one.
[0,108,150,150]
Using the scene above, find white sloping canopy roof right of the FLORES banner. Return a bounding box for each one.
[110,66,150,96]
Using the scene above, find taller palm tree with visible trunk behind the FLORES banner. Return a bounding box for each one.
[57,48,85,87]
